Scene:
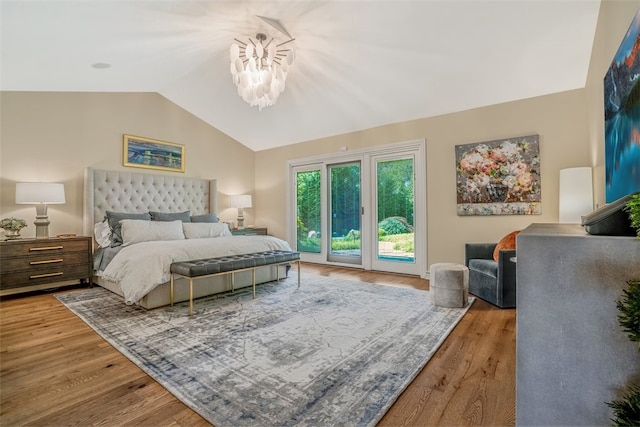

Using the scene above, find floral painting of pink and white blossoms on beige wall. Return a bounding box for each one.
[456,135,542,215]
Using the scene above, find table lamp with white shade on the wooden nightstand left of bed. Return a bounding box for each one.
[16,182,65,239]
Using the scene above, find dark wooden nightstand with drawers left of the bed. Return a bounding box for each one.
[0,237,93,296]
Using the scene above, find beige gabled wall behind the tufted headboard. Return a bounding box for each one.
[0,92,254,237]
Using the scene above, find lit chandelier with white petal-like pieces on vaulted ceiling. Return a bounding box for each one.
[229,33,295,110]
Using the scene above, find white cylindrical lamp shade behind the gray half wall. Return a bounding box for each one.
[559,167,593,224]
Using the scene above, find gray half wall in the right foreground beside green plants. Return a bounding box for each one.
[516,224,640,426]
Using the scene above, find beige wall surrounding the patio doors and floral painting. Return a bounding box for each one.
[256,0,640,266]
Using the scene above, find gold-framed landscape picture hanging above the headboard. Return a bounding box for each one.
[122,135,185,172]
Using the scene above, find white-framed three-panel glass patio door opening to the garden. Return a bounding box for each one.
[287,141,426,276]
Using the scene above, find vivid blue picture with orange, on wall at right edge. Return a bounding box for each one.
[604,10,640,203]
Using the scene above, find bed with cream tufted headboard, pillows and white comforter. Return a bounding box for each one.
[83,168,291,309]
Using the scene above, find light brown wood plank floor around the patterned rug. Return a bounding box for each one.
[0,264,516,426]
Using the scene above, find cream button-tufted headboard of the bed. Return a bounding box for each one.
[82,168,218,236]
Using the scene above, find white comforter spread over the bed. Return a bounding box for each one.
[100,236,291,304]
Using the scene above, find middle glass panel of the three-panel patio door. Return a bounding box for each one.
[328,162,362,264]
